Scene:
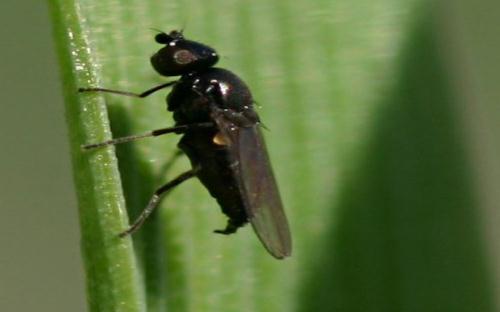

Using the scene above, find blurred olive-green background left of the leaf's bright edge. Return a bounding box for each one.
[0,0,86,311]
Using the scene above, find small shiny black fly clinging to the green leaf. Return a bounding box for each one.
[78,30,292,259]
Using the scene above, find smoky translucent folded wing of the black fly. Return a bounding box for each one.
[215,115,292,259]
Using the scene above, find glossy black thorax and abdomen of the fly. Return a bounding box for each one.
[167,67,254,234]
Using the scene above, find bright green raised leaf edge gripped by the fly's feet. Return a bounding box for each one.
[50,0,145,311]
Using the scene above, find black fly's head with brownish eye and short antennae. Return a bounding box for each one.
[151,30,219,76]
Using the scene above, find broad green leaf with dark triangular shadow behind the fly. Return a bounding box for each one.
[51,0,493,311]
